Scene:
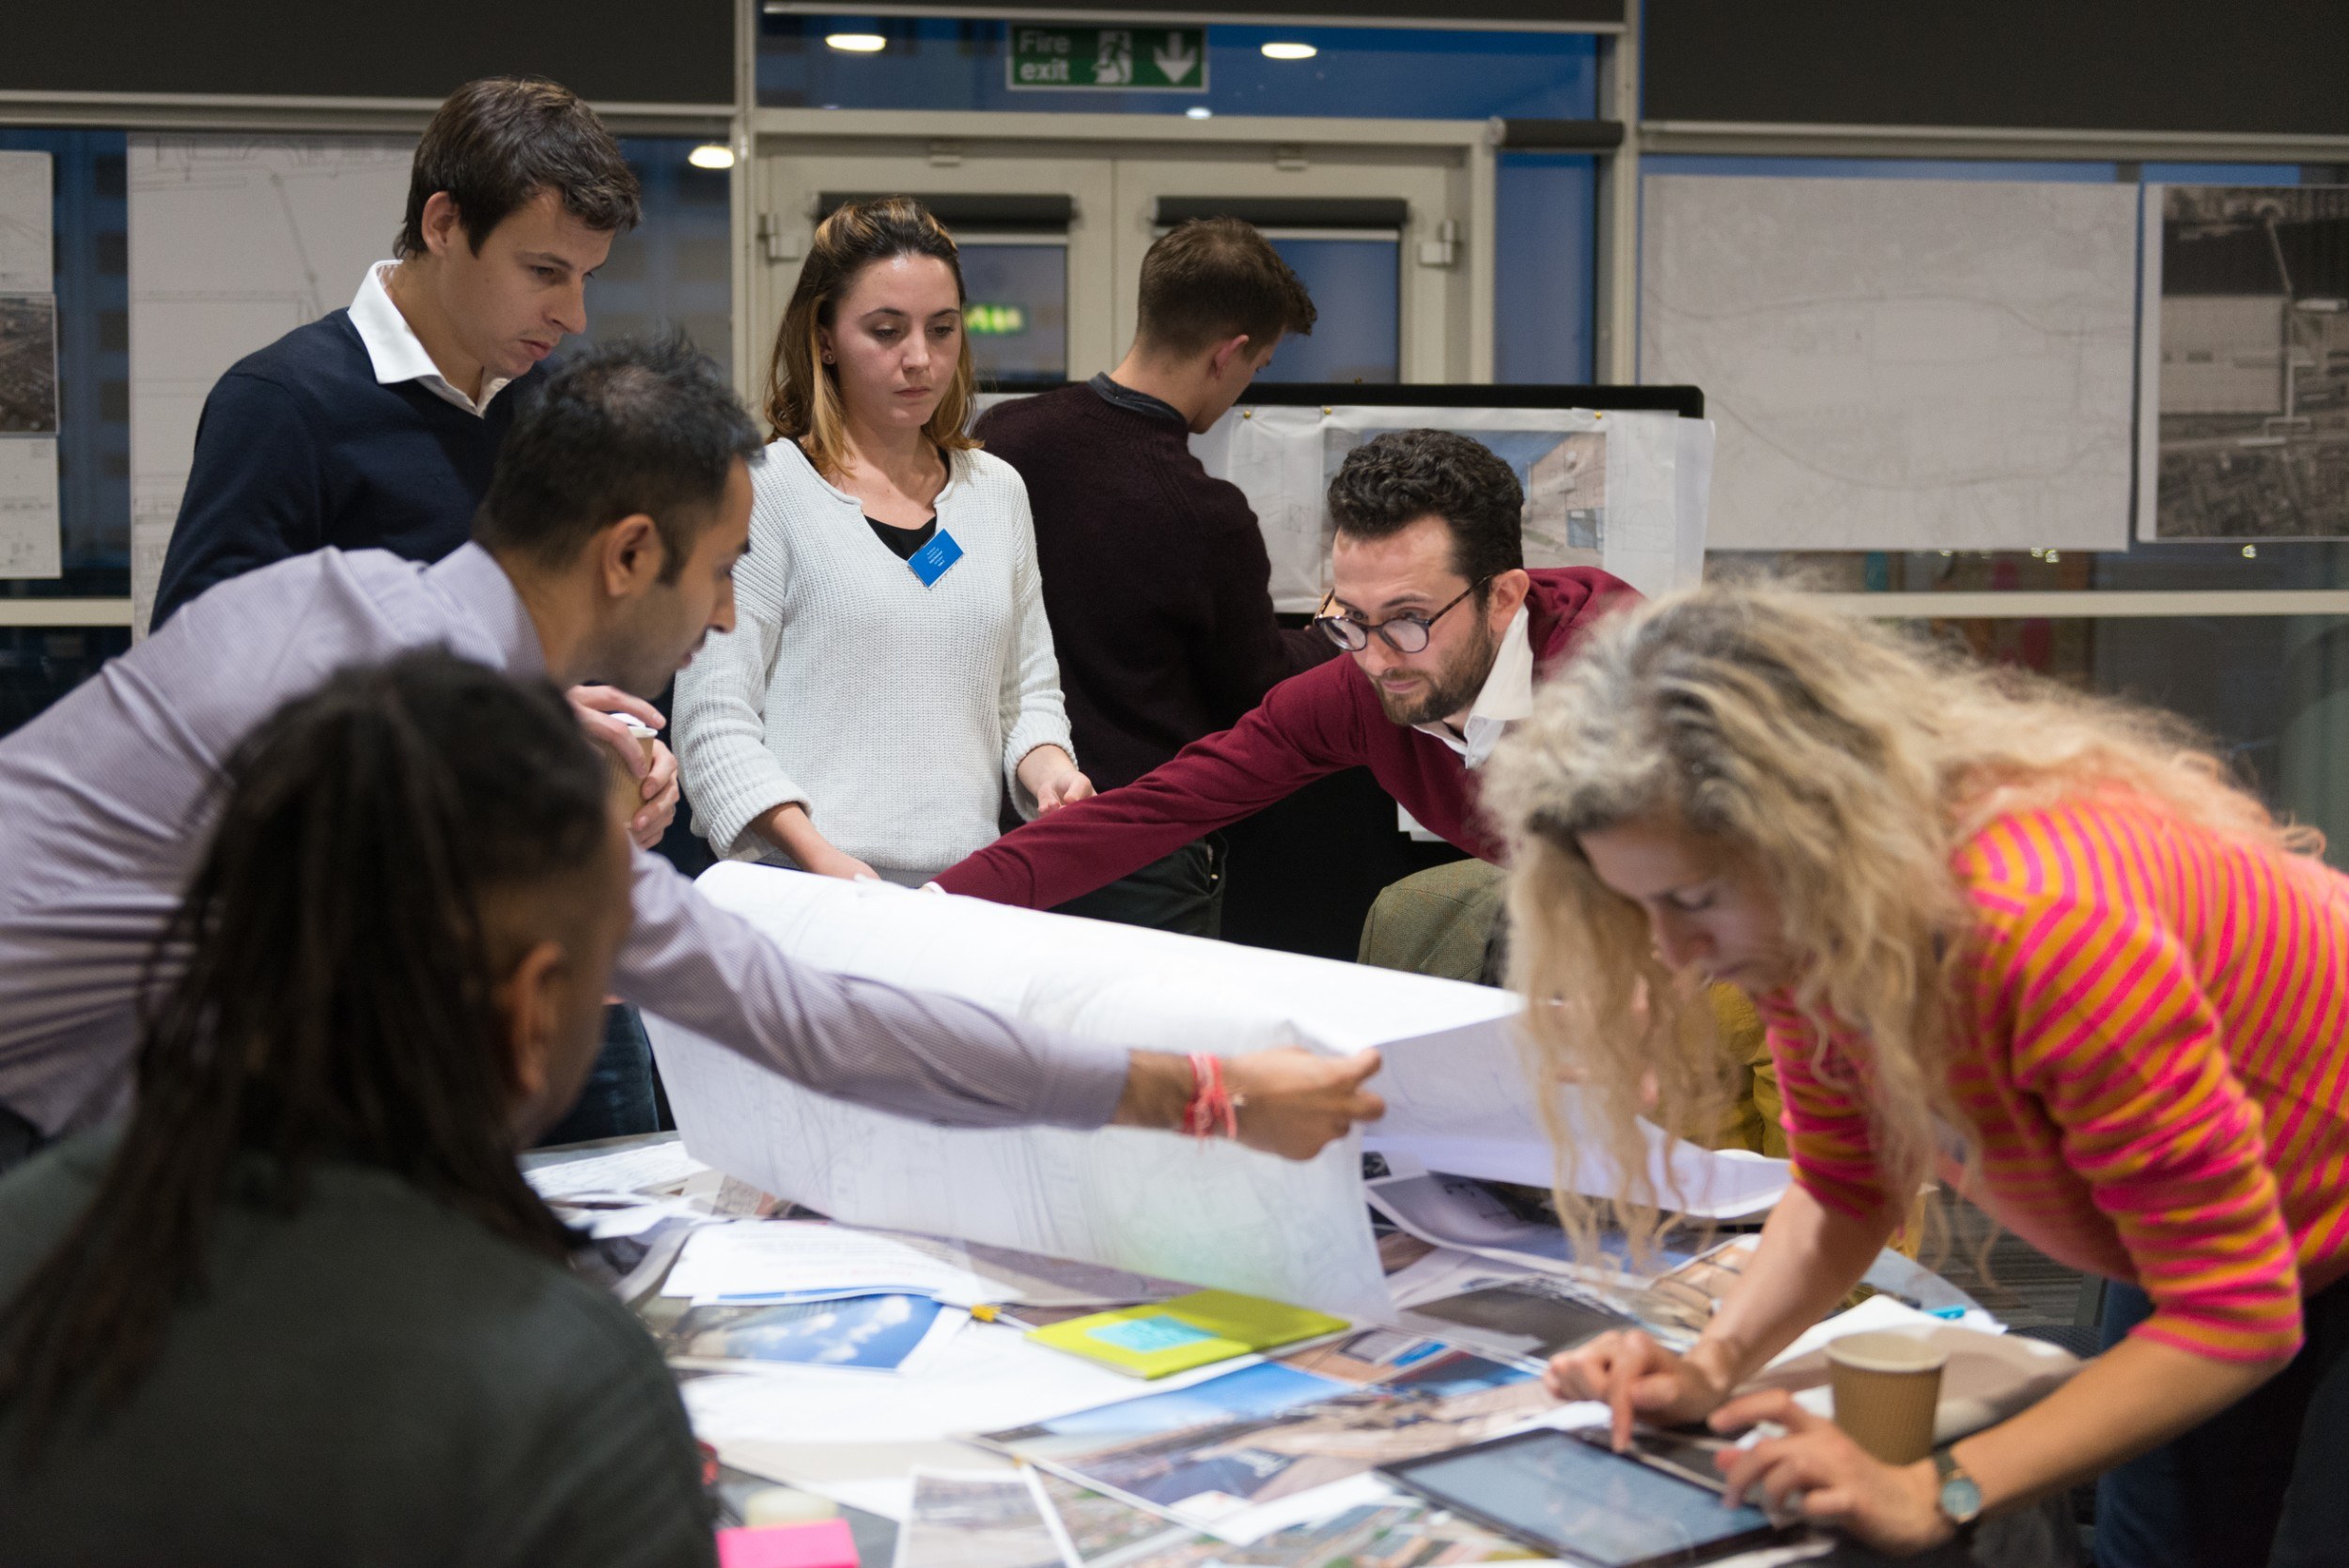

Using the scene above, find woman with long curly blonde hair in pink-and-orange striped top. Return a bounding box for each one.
[1485,587,2349,1568]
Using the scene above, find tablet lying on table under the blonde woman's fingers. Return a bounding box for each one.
[1379,1427,1781,1568]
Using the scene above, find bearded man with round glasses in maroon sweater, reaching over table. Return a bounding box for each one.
[938,429,1630,908]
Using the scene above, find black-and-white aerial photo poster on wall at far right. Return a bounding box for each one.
[2138,185,2349,545]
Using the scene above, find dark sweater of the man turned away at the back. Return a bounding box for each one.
[975,385,1337,798]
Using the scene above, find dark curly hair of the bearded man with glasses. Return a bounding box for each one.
[1330,429,1525,601]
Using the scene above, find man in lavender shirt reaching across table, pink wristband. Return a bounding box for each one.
[0,343,1381,1167]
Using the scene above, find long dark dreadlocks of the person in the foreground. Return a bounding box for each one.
[0,648,611,1463]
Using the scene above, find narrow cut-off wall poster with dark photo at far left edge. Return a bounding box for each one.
[0,152,64,578]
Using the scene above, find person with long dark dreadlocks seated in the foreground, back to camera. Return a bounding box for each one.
[0,653,712,1568]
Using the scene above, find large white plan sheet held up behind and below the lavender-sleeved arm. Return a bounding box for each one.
[648,863,1513,1317]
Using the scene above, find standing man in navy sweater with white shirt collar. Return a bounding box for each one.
[155,77,677,1141]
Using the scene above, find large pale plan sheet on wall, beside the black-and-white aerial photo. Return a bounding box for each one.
[1640,174,2138,550]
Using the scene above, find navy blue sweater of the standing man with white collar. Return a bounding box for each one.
[155,310,545,627]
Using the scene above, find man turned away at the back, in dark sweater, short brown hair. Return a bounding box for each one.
[975,218,1337,937]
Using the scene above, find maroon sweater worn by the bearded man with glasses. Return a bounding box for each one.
[938,566,1630,908]
